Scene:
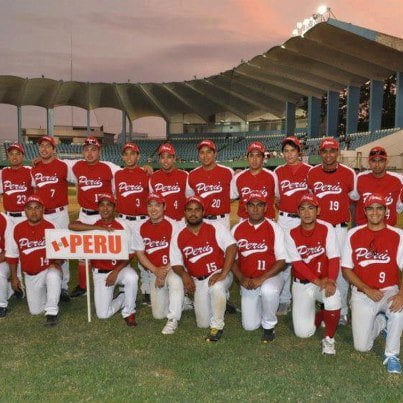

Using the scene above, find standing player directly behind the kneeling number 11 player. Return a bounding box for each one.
[231,141,277,223]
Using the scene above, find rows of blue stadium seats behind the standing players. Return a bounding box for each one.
[4,128,400,165]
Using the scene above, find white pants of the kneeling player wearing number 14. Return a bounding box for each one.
[24,268,62,315]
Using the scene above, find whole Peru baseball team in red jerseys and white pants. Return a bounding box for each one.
[0,136,403,374]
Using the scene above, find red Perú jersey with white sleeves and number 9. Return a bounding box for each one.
[341,225,403,289]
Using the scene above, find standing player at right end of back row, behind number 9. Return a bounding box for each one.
[353,147,403,225]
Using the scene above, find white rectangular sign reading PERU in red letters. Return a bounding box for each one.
[45,229,129,260]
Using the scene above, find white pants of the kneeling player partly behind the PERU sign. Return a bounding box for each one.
[92,266,139,319]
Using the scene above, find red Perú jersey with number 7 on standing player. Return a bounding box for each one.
[31,158,71,210]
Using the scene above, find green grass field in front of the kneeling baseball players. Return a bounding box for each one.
[0,192,403,402]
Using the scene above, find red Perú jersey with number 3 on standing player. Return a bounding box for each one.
[115,166,149,216]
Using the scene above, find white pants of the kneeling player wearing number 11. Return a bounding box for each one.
[241,273,284,330]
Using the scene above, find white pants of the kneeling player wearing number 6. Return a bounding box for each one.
[150,269,185,321]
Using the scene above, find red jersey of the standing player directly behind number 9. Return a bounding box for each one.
[353,171,403,225]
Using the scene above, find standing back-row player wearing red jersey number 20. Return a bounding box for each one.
[189,140,234,229]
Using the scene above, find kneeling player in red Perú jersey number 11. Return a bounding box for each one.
[232,191,286,343]
